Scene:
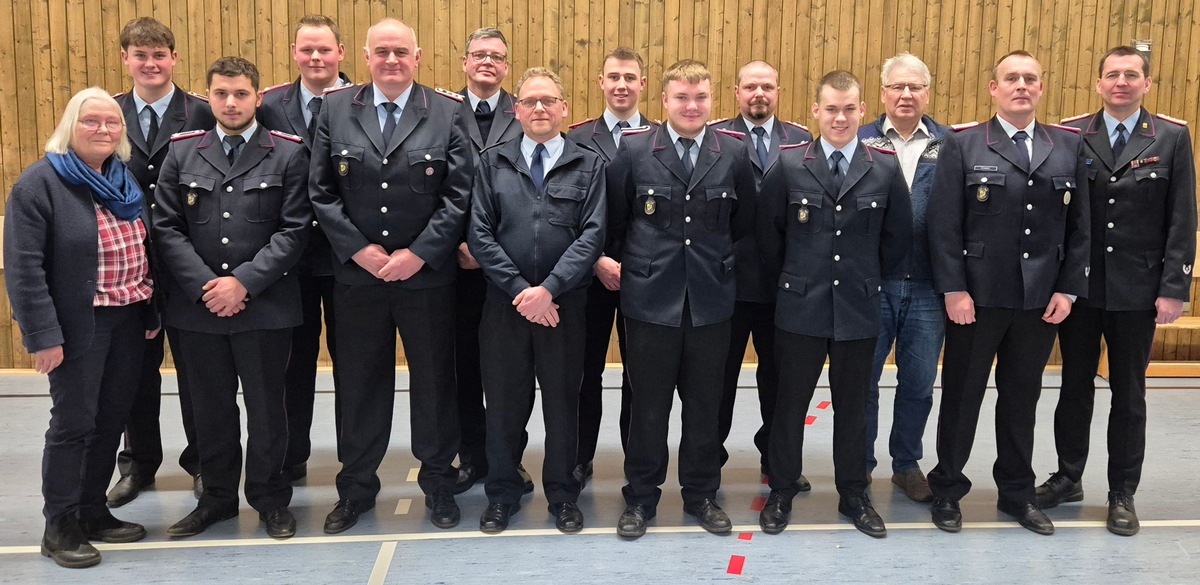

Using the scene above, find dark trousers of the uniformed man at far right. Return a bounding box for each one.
[1054,307,1157,495]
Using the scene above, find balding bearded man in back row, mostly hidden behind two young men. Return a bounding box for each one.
[713,61,812,484]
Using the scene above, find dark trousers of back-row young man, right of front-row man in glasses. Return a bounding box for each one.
[575,278,630,465]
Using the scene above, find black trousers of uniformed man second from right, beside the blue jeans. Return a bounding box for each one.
[929,307,1056,502]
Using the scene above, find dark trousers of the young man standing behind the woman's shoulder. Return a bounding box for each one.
[116,327,200,478]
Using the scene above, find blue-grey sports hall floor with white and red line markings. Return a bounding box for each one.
[0,369,1200,585]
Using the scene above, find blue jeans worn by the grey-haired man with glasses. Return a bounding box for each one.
[866,281,946,474]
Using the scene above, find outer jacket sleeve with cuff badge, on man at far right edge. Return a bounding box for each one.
[1158,127,1196,301]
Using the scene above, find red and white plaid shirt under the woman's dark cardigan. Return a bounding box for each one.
[91,203,154,307]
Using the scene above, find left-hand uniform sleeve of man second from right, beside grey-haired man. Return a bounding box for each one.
[925,133,970,294]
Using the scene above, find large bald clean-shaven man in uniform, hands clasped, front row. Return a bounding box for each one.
[310,18,475,533]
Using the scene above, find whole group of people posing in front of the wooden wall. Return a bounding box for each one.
[5,16,1196,567]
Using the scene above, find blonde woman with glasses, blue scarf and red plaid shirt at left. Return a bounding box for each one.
[4,88,158,568]
